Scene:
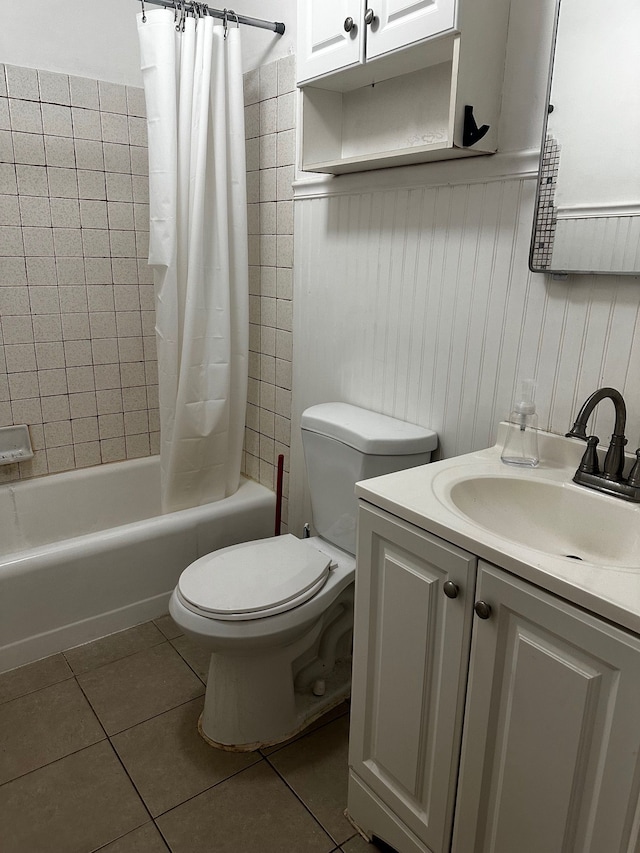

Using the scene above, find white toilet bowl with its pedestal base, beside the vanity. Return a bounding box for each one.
[169,536,355,751]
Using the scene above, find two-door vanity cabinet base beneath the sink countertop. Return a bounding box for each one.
[348,503,640,853]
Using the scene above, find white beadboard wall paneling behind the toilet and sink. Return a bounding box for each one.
[289,172,640,532]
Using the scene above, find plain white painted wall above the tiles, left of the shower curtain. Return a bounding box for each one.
[0,0,142,86]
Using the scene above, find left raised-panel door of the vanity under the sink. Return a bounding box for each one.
[349,504,476,853]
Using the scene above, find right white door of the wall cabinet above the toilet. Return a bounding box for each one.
[367,0,456,59]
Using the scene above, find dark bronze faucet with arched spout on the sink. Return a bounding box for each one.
[567,388,640,503]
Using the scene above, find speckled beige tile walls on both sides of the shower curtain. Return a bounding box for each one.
[0,56,296,512]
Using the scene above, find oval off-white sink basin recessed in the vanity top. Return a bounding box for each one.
[441,475,640,569]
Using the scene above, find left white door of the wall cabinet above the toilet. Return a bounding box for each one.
[297,0,365,83]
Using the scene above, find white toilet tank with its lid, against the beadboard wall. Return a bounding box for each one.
[300,403,438,554]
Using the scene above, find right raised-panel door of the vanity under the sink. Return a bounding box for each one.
[452,564,640,853]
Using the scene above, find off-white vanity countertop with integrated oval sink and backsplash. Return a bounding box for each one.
[356,424,640,636]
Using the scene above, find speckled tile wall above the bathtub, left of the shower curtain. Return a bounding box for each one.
[0,65,158,482]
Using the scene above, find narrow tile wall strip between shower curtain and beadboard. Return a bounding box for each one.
[244,56,296,530]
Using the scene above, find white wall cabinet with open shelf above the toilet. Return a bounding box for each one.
[297,0,509,174]
